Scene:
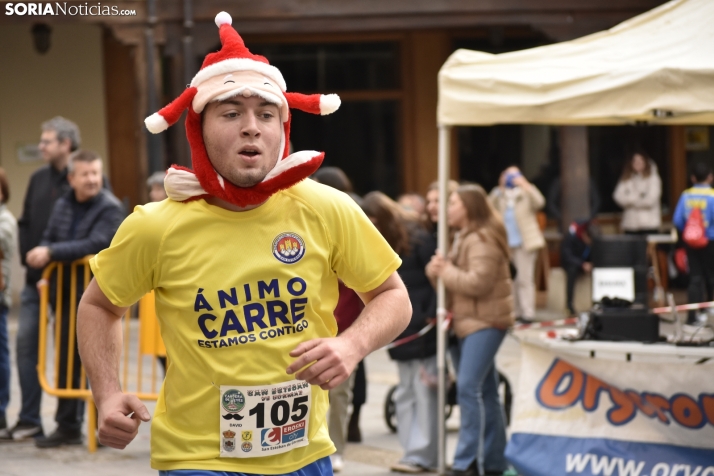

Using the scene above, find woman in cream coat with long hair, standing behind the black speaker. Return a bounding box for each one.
[612,151,662,235]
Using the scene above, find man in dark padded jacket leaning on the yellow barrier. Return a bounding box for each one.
[26,150,124,448]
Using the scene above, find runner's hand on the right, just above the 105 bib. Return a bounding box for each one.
[286,336,363,390]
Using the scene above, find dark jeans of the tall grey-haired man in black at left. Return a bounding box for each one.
[16,284,42,426]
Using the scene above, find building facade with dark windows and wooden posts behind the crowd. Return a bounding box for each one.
[0,0,711,218]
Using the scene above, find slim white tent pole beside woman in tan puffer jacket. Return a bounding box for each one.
[436,125,451,475]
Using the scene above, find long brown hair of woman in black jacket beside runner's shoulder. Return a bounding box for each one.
[362,192,411,255]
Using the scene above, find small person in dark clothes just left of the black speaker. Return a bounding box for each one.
[560,220,593,315]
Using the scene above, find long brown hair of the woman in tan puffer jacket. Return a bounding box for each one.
[455,184,510,258]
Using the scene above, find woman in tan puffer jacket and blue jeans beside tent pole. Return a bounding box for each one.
[426,185,513,476]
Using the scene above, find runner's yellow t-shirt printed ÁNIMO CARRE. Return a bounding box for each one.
[91,180,401,474]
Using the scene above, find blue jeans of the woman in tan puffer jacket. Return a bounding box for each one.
[453,328,508,474]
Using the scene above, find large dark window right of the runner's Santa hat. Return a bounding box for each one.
[249,41,401,197]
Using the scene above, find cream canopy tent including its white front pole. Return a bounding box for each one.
[428,0,714,474]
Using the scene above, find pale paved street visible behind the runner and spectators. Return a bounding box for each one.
[0,306,536,476]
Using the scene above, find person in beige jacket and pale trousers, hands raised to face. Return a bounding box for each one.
[489,167,545,320]
